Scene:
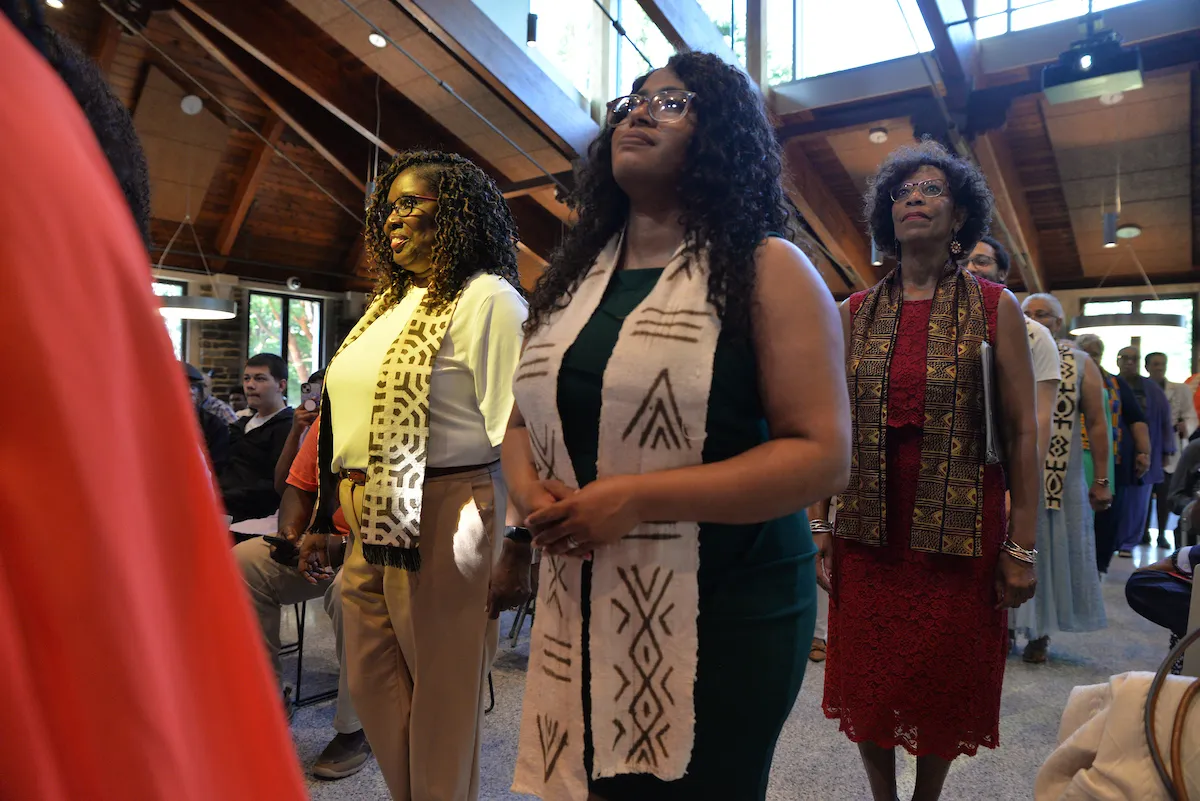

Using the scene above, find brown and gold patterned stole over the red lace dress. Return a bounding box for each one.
[834,264,988,556]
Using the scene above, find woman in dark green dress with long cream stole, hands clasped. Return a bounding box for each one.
[504,53,848,801]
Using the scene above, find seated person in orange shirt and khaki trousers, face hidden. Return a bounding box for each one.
[233,419,371,778]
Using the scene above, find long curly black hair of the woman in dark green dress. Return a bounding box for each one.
[526,53,790,335]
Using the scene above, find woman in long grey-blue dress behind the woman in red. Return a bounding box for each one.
[1014,294,1112,664]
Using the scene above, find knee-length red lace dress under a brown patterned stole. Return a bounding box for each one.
[823,282,1008,759]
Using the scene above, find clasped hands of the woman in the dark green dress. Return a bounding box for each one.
[524,476,642,559]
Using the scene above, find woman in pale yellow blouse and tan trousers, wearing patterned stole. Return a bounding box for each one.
[280,151,529,801]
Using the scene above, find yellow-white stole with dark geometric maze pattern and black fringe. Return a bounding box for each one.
[316,290,457,571]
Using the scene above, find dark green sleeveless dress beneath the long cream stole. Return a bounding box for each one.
[558,270,816,801]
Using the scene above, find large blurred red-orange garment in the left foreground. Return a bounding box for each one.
[0,16,306,801]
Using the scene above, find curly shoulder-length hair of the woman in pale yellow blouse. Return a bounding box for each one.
[365,150,522,309]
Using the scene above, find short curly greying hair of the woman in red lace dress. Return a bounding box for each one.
[863,139,995,258]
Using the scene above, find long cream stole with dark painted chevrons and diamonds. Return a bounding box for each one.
[514,237,720,801]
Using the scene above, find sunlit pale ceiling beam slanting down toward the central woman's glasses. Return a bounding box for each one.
[392,0,600,161]
